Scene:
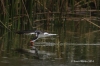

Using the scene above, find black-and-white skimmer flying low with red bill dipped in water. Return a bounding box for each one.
[16,30,57,57]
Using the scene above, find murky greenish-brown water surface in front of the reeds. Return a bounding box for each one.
[0,27,100,66]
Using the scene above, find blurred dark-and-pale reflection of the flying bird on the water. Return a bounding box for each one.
[15,49,56,59]
